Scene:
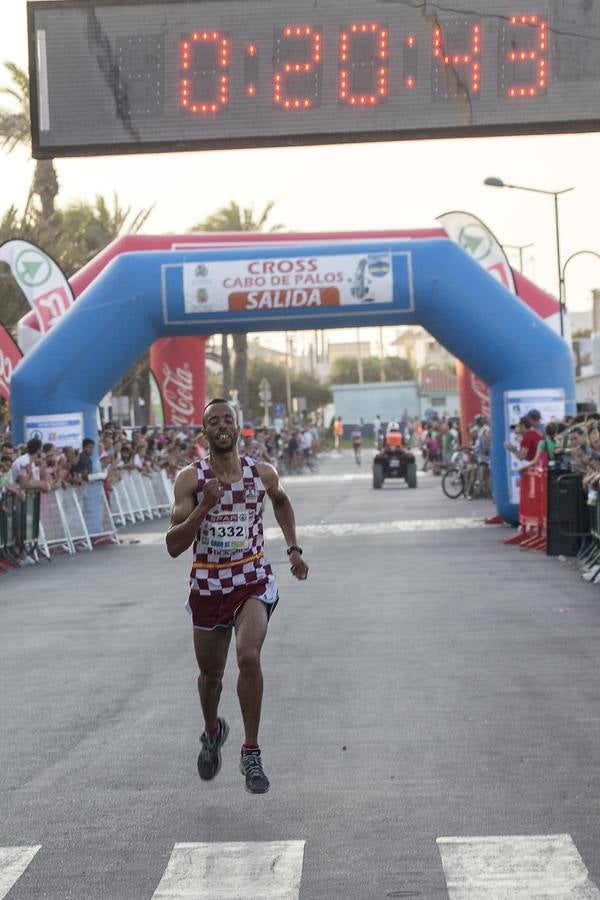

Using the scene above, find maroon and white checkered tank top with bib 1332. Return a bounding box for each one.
[190,456,274,596]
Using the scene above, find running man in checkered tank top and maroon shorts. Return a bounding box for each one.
[166,399,308,794]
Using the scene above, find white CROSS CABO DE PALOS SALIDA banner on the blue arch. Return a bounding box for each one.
[183,252,394,314]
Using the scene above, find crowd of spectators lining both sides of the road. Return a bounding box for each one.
[0,409,600,502]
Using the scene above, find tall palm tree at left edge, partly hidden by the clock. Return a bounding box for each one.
[0,62,58,221]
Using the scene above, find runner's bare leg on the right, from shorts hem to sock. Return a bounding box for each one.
[235,597,268,746]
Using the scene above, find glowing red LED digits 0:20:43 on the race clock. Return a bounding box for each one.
[157,13,550,116]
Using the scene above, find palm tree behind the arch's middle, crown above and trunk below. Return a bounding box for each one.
[191,200,283,410]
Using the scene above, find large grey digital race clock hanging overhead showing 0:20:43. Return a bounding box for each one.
[28,0,600,158]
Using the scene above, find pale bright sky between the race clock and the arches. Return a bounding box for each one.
[0,0,600,356]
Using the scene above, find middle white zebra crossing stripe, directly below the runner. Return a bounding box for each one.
[152,841,304,900]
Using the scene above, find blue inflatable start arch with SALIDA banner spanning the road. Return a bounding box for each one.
[11,238,575,522]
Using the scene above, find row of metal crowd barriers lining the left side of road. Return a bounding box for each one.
[0,470,174,573]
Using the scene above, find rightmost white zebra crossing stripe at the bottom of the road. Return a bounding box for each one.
[437,834,600,900]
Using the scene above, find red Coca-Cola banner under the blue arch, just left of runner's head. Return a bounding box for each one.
[150,337,205,425]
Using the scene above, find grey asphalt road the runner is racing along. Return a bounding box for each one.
[0,454,600,900]
